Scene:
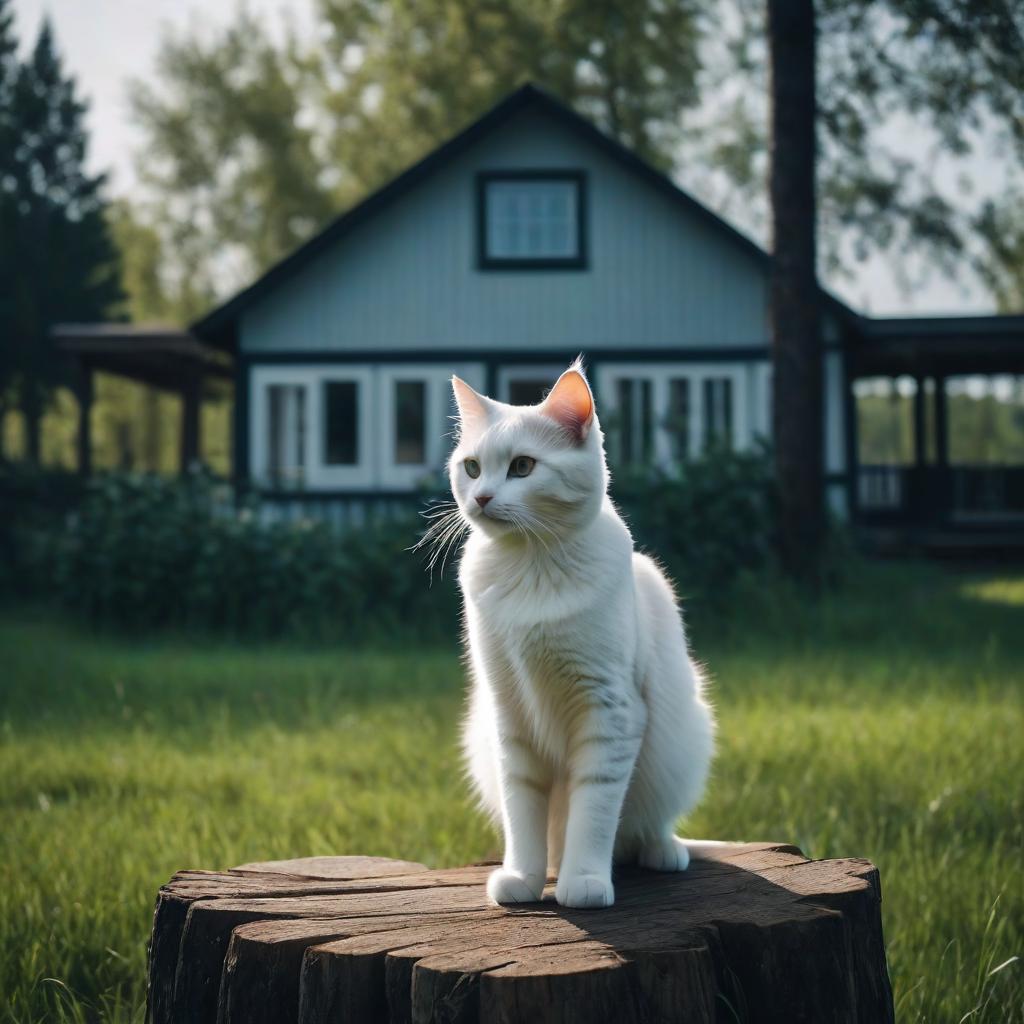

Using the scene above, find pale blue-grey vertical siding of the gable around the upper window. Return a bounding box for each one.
[241,112,767,353]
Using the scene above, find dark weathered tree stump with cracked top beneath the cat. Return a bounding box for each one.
[147,844,893,1024]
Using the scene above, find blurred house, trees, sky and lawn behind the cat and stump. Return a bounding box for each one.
[0,0,1024,1024]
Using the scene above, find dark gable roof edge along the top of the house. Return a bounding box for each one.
[190,82,856,349]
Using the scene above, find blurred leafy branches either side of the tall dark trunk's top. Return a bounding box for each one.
[702,0,1024,287]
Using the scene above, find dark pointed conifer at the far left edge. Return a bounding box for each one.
[0,20,121,462]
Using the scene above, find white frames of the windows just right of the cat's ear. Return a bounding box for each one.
[596,362,752,469]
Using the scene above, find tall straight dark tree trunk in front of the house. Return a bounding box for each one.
[768,0,824,582]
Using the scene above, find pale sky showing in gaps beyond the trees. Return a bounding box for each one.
[13,0,998,315]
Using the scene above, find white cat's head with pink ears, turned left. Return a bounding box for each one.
[449,359,608,544]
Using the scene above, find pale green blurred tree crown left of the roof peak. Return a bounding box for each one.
[131,10,337,305]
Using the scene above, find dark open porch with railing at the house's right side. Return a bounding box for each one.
[847,315,1024,550]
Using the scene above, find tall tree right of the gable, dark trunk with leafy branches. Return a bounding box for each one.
[753,0,1024,580]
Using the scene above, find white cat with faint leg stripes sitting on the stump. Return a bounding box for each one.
[449,360,714,907]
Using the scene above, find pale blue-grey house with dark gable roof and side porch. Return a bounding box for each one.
[61,85,1024,544]
